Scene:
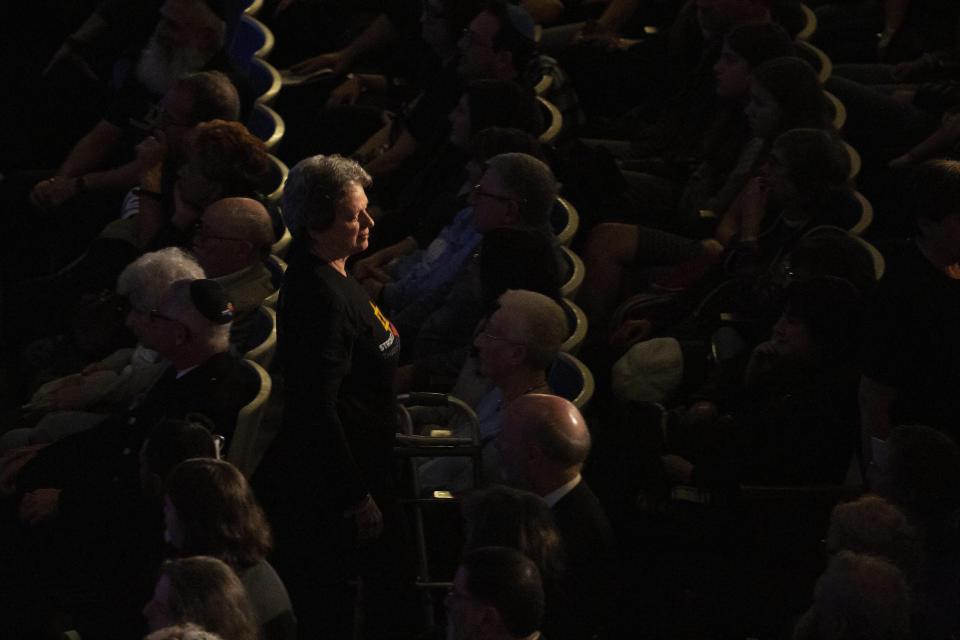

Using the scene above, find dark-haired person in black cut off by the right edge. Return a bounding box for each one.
[860,160,960,460]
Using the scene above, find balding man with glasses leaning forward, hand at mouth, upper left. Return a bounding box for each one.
[3,71,241,286]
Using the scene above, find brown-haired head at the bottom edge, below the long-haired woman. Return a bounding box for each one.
[143,556,259,640]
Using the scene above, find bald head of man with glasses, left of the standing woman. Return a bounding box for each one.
[193,198,273,278]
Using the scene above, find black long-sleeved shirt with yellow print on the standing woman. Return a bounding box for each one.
[267,246,400,508]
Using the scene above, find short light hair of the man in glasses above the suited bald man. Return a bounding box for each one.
[497,289,569,370]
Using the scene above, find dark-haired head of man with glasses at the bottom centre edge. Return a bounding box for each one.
[445,547,544,640]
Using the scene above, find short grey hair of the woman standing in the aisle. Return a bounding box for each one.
[281,155,373,238]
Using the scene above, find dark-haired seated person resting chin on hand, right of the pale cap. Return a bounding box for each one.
[662,277,861,486]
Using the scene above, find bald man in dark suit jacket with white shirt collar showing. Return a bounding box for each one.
[496,394,617,639]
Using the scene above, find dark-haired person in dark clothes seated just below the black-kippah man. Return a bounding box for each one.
[0,418,215,639]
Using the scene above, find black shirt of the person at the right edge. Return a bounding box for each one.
[863,241,960,437]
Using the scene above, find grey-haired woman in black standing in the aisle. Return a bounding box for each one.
[253,156,400,636]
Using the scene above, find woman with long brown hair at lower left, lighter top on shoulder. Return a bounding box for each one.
[164,458,297,640]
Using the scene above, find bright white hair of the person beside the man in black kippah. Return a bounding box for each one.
[117,247,205,309]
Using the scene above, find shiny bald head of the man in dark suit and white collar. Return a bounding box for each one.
[497,393,590,495]
